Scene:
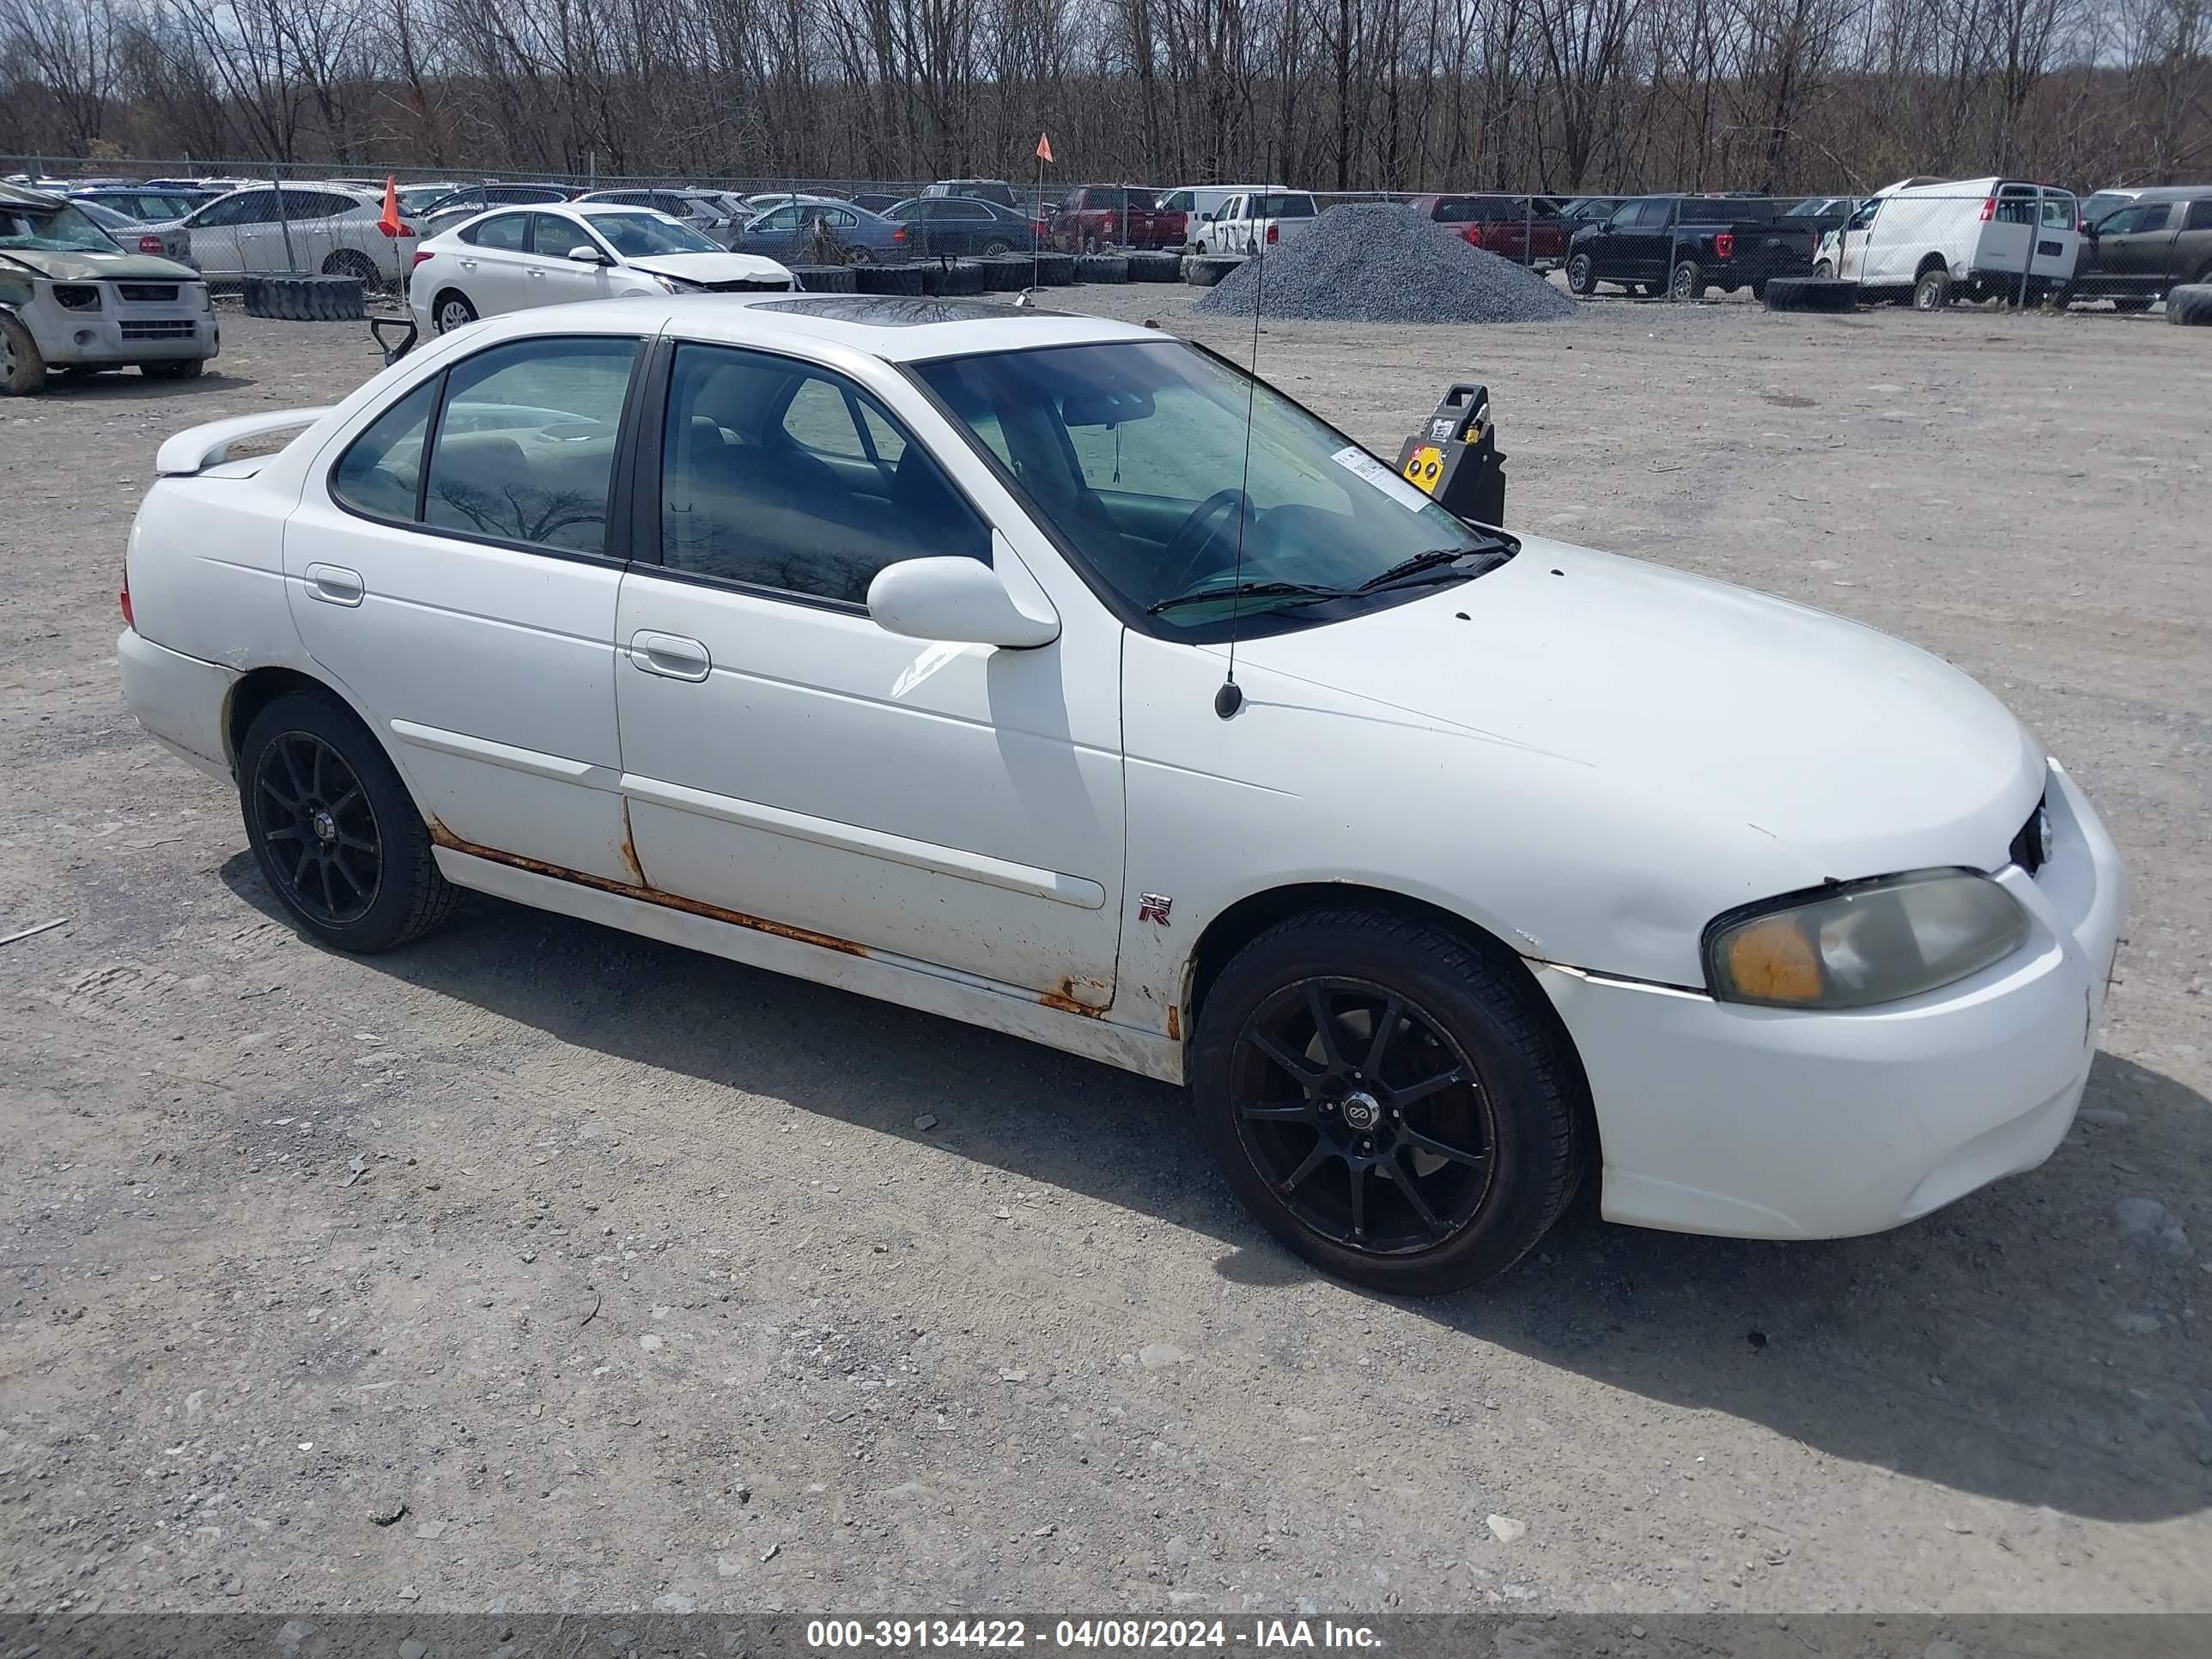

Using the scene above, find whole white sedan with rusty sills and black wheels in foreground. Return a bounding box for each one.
[119,295,2126,1291]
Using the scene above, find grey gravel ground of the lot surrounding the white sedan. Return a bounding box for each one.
[0,298,2212,1627]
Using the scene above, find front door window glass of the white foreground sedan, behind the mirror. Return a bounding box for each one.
[661,345,991,606]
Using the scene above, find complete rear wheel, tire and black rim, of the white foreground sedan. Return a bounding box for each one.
[239,692,458,956]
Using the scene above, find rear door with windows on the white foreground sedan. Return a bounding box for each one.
[283,337,639,880]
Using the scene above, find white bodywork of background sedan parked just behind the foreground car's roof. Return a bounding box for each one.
[407,201,792,337]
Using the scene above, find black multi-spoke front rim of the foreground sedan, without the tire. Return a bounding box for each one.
[1230,975,1495,1256]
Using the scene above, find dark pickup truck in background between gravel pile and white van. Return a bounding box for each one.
[1566,197,1814,301]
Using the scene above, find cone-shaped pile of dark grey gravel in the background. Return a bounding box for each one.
[1197,201,1575,323]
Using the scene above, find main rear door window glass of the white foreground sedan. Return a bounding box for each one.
[422,338,637,553]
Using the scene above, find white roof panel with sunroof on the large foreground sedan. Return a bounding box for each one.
[464,295,1170,362]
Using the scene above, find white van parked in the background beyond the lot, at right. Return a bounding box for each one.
[1820,179,2081,312]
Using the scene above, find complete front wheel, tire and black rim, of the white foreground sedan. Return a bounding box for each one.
[1190,909,1586,1297]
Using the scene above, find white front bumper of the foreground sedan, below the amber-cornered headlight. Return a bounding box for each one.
[1537,761,2128,1239]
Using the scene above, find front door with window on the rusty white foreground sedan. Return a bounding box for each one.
[615,345,1121,1009]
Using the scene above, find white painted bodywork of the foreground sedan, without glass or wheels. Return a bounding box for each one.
[119,299,2126,1237]
